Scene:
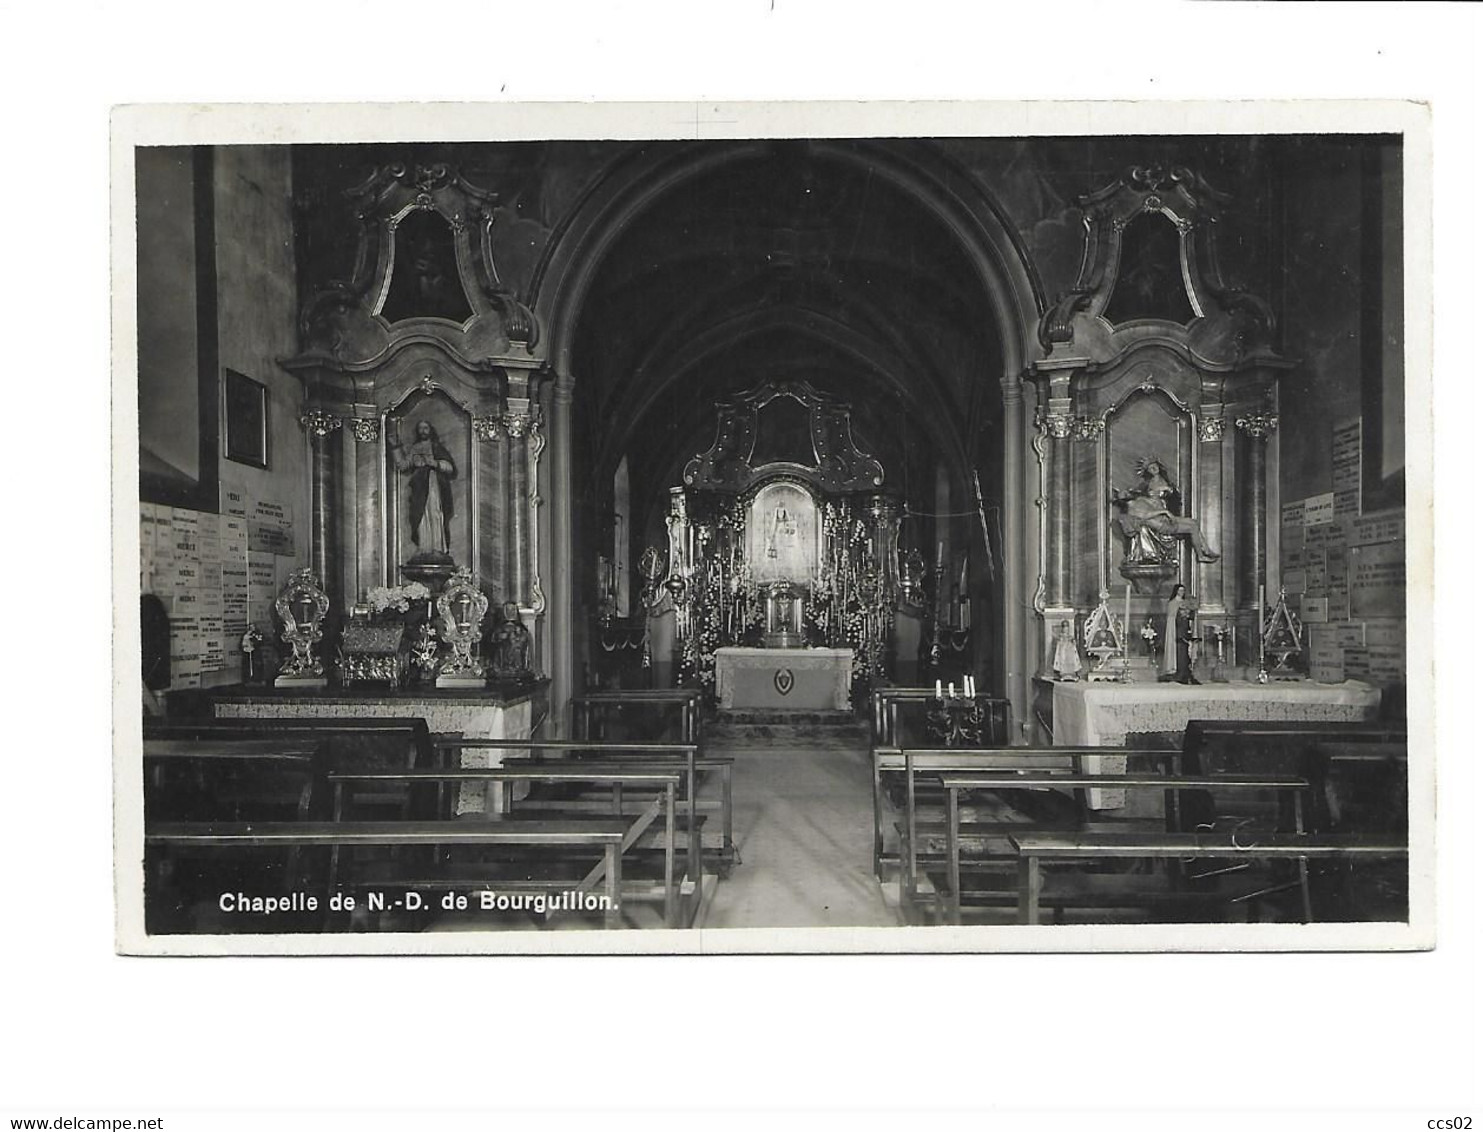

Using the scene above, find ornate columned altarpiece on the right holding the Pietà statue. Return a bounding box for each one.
[1029,166,1293,672]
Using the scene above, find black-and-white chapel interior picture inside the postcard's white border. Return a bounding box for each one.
[133,135,1410,935]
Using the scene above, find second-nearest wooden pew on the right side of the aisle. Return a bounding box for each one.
[936,770,1308,924]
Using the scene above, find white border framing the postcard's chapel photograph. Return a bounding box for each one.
[111,101,1436,955]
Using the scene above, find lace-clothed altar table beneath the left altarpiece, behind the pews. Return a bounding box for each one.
[212,679,550,815]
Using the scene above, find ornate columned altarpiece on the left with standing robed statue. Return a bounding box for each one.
[283,165,546,655]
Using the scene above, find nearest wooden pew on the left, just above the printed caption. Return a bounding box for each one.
[144,819,627,927]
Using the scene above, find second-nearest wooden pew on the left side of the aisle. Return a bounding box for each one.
[329,763,685,927]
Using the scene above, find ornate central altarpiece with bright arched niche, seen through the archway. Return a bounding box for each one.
[663,381,900,685]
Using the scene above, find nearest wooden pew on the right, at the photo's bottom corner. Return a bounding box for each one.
[1010,834,1406,924]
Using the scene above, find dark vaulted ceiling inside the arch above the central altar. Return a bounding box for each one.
[572,142,1000,510]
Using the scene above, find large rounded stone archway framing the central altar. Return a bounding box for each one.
[531,141,1044,735]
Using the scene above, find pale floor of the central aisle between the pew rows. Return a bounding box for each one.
[698,739,899,927]
